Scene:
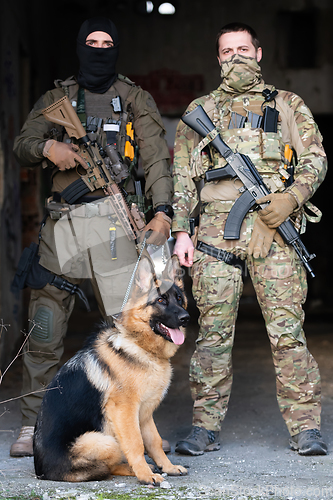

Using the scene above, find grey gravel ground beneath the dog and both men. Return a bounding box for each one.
[0,294,333,500]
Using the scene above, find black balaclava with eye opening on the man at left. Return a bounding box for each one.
[76,17,119,94]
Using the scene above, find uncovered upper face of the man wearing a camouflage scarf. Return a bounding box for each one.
[217,31,262,66]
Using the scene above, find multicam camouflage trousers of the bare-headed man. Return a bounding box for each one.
[190,243,321,435]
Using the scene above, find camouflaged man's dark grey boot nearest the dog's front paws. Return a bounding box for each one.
[175,426,220,455]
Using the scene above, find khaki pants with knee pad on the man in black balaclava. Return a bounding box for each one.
[21,206,137,425]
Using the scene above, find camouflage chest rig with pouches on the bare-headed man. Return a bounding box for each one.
[194,85,292,191]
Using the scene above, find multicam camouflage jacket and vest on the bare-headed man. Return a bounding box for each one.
[172,81,327,238]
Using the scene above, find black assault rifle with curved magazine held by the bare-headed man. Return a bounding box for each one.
[182,105,315,278]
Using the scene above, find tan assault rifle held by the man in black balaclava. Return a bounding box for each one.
[43,96,145,241]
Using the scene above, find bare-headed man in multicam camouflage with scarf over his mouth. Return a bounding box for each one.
[172,23,327,455]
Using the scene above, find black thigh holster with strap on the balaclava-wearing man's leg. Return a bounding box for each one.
[11,243,90,311]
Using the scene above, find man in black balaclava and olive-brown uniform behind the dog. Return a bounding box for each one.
[10,17,173,457]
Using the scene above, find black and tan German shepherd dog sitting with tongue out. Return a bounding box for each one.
[34,256,189,486]
